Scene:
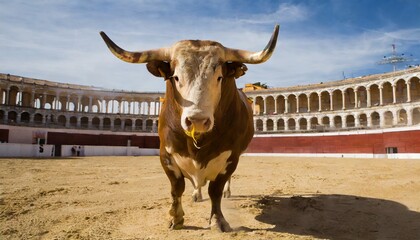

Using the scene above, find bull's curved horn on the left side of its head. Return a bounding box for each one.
[100,31,171,63]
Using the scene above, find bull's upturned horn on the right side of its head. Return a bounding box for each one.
[225,24,280,64]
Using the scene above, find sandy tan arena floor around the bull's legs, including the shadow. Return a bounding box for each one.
[0,157,420,240]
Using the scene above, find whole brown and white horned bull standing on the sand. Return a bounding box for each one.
[100,25,279,232]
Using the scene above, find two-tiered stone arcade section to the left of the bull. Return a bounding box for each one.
[0,74,163,132]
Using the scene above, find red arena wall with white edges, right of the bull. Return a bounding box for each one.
[247,127,420,159]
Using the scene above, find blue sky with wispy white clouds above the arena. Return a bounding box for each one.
[0,0,420,91]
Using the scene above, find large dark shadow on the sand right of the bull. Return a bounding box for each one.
[243,195,420,239]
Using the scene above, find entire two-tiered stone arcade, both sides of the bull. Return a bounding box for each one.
[0,67,420,133]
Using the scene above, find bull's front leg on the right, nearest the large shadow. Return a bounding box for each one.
[209,175,232,232]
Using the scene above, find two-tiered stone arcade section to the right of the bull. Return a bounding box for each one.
[246,68,420,133]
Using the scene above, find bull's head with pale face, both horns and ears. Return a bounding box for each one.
[100,25,279,136]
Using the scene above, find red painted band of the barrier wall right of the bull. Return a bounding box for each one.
[247,130,420,154]
